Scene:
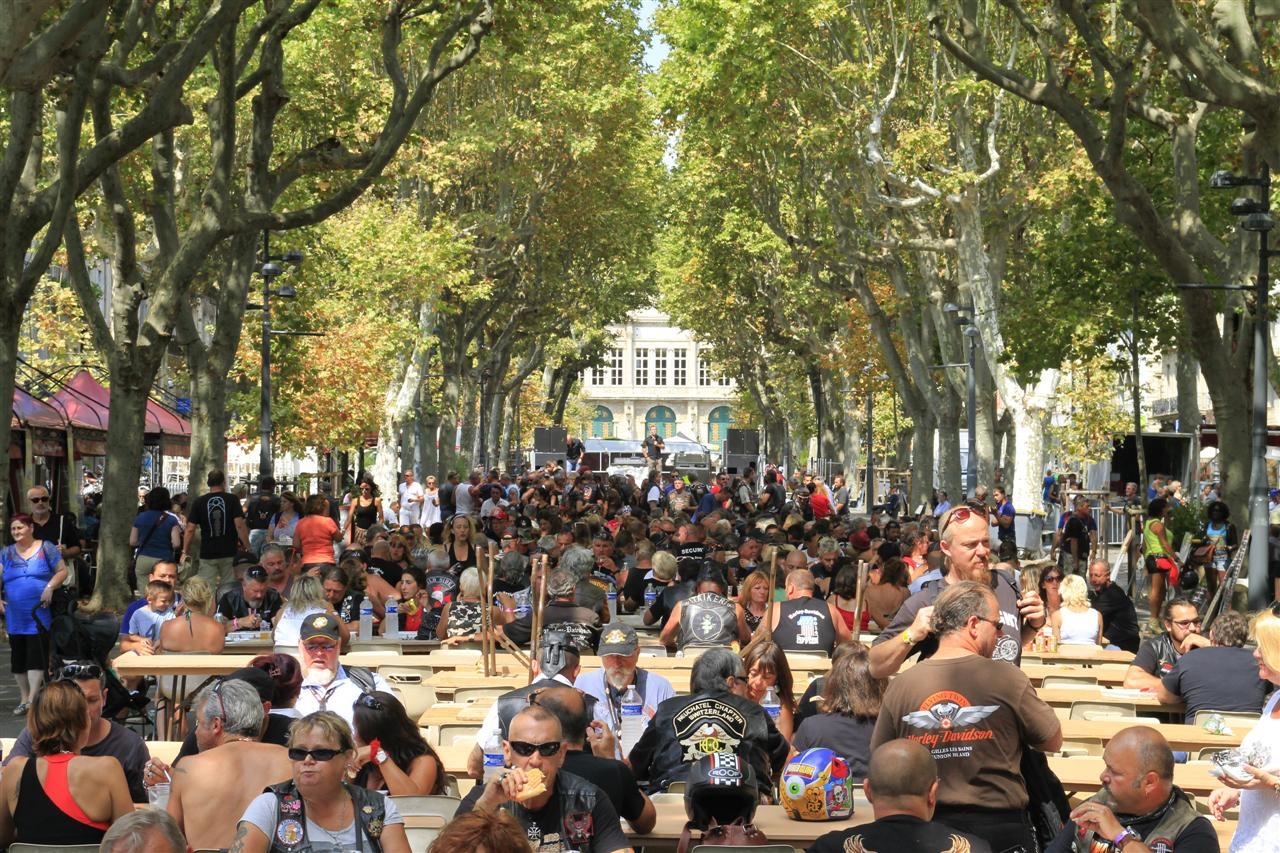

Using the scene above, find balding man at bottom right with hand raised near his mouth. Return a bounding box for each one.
[1046,726,1220,853]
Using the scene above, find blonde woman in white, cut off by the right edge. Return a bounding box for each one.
[1208,605,1280,853]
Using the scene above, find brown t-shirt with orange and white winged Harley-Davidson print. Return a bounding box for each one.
[872,654,1062,808]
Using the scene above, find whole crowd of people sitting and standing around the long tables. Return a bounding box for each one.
[0,455,1280,853]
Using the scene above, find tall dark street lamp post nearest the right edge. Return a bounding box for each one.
[1208,163,1275,610]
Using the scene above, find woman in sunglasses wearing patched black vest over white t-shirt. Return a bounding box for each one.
[230,711,410,853]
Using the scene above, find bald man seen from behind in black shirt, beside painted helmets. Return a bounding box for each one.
[808,738,991,853]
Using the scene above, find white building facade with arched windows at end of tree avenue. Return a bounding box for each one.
[575,309,736,452]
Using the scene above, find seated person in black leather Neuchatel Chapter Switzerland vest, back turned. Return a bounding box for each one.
[630,648,790,794]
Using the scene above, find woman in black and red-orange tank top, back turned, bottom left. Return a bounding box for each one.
[0,680,133,845]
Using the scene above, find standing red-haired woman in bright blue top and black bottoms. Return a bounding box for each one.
[0,512,67,716]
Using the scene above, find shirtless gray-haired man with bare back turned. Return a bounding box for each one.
[166,680,293,849]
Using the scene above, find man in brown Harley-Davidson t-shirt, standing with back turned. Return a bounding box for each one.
[872,578,1062,850]
